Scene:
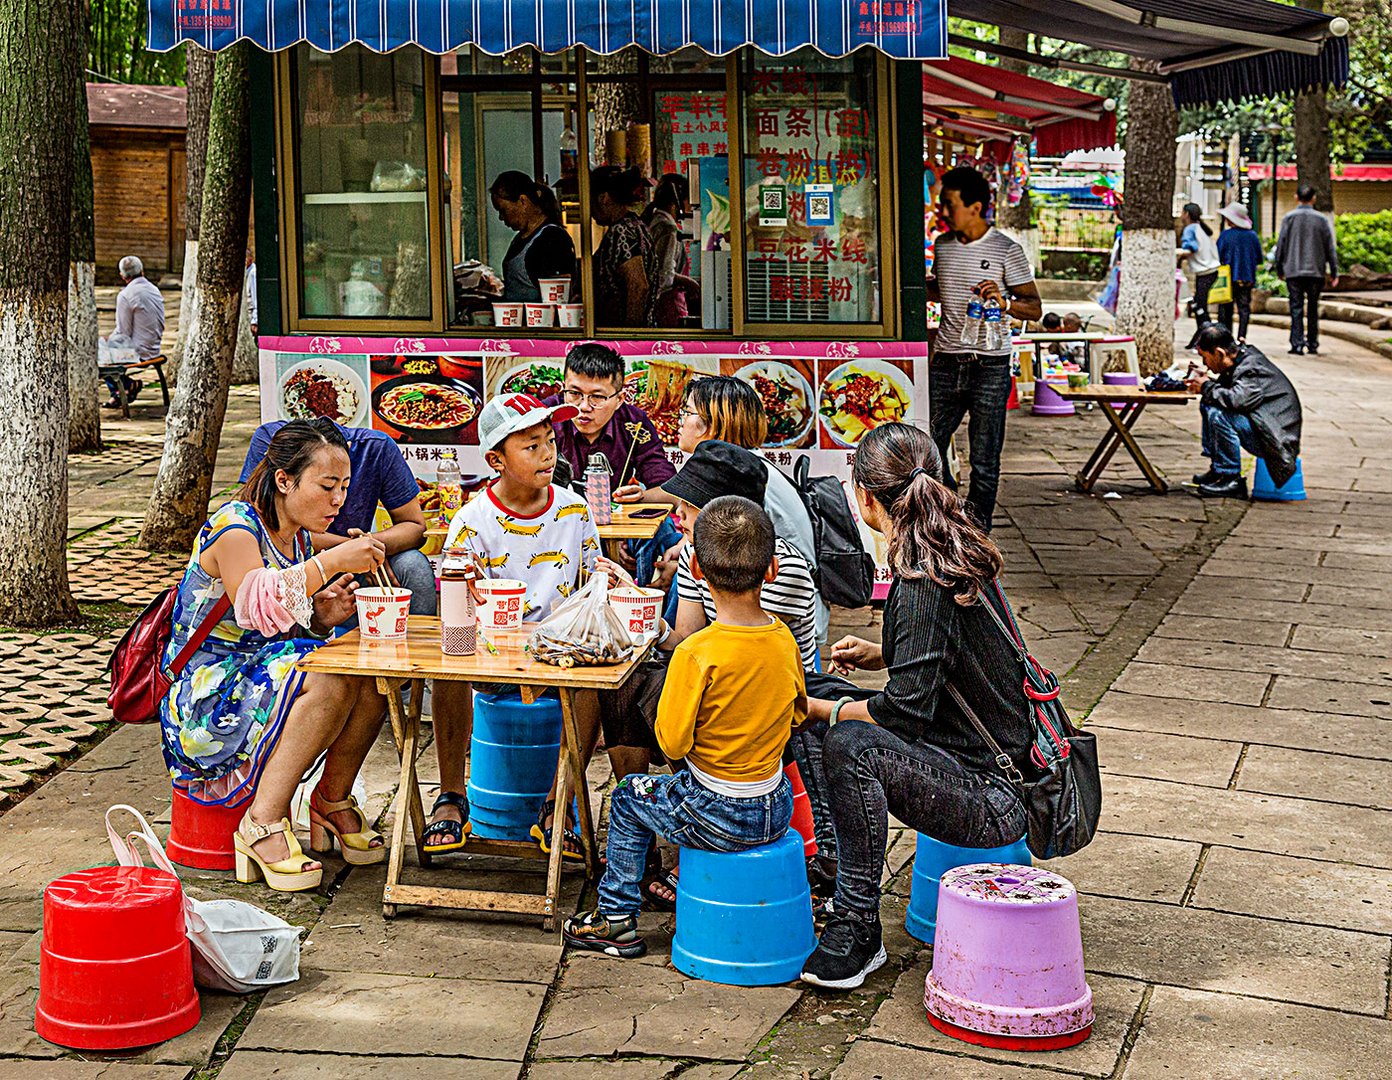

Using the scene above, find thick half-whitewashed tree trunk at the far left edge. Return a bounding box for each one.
[0,0,85,626]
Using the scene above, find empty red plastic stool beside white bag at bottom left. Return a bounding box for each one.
[33,866,199,1049]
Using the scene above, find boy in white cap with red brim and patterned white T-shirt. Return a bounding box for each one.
[425,394,600,856]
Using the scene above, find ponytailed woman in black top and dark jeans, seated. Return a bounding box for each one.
[802,423,1031,990]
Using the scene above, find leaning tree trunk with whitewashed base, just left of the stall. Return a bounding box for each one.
[141,42,251,553]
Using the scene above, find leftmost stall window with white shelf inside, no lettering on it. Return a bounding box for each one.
[287,45,438,328]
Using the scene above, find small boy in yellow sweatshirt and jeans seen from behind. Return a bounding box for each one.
[564,495,807,956]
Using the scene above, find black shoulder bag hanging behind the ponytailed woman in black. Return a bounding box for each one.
[948,583,1102,859]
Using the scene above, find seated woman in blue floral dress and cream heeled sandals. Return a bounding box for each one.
[160,420,398,891]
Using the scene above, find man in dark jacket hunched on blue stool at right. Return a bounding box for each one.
[1186,323,1300,498]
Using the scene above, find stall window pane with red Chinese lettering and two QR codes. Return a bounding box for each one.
[741,49,894,335]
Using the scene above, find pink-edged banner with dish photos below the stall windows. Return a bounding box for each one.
[260,337,928,586]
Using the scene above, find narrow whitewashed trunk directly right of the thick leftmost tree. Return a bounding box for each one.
[68,44,102,452]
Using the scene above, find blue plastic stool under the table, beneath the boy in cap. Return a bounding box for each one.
[468,693,561,841]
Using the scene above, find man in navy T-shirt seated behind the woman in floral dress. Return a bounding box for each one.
[242,420,437,615]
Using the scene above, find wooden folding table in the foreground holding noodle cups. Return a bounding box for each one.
[296,615,647,930]
